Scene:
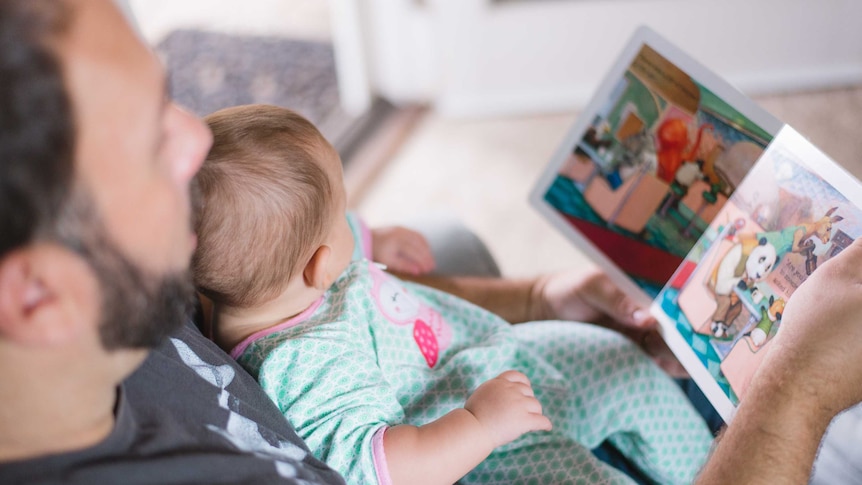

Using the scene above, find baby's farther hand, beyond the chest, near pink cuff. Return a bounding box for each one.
[371,226,434,275]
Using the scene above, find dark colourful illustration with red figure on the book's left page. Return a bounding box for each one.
[544,45,772,296]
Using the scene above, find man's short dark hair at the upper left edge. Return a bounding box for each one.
[0,0,75,258]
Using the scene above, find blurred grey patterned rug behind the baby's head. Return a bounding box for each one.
[156,30,355,146]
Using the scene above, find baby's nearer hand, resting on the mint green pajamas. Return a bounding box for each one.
[464,370,551,448]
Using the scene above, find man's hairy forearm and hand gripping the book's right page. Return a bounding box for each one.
[697,239,862,484]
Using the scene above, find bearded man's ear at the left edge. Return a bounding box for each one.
[0,245,99,345]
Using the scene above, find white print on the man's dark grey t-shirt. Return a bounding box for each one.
[171,338,307,478]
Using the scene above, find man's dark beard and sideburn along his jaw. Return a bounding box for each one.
[58,187,195,350]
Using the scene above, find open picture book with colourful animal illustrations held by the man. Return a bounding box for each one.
[530,28,862,421]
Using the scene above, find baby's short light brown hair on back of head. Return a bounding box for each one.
[192,105,336,308]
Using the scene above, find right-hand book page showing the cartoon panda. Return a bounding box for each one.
[651,127,862,421]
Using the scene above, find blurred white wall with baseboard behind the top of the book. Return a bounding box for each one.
[364,0,862,116]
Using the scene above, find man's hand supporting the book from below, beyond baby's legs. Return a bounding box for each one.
[531,270,688,377]
